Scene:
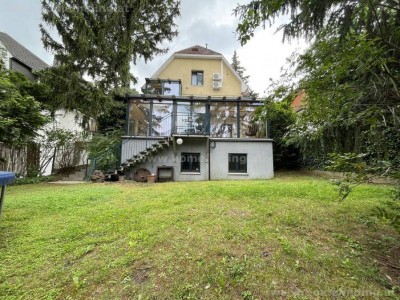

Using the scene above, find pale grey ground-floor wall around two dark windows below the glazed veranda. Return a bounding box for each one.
[123,136,274,181]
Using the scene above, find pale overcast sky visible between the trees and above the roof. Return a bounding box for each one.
[0,0,305,96]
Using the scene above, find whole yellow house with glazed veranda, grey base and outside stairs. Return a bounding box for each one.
[121,46,274,181]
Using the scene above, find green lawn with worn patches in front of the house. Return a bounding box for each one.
[0,176,400,299]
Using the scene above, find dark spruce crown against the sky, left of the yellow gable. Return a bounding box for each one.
[40,0,180,89]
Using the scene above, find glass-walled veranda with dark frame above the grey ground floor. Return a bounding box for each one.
[126,95,265,138]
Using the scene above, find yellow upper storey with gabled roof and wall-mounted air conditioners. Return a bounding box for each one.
[147,46,248,97]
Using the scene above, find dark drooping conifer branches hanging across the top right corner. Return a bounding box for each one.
[234,0,400,45]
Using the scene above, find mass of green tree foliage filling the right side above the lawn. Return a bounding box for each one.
[235,0,400,176]
